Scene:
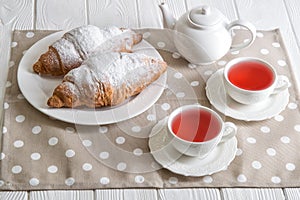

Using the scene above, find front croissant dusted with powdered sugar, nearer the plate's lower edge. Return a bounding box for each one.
[47,52,167,108]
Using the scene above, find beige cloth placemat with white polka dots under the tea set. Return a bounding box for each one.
[0,29,300,190]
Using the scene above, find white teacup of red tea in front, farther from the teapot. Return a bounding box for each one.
[168,104,237,158]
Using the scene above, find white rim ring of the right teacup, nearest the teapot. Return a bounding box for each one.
[223,56,278,93]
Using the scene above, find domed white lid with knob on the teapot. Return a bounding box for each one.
[188,5,224,27]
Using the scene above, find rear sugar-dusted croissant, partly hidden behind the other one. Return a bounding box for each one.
[33,25,142,76]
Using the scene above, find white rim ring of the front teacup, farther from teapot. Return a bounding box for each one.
[167,104,225,145]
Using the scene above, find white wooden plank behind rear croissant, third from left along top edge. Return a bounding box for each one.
[87,0,139,28]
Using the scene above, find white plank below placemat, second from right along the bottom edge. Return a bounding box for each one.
[221,188,285,200]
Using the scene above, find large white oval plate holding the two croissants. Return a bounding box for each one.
[17,31,167,125]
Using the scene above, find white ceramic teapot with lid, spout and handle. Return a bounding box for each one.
[160,3,256,65]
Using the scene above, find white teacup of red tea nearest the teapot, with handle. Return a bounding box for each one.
[223,57,290,104]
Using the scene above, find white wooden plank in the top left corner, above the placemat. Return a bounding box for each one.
[0,0,34,29]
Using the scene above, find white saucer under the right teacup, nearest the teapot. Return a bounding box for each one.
[206,69,290,121]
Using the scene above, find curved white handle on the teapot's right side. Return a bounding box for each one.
[227,20,256,52]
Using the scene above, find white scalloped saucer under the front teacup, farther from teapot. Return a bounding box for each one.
[149,117,237,176]
